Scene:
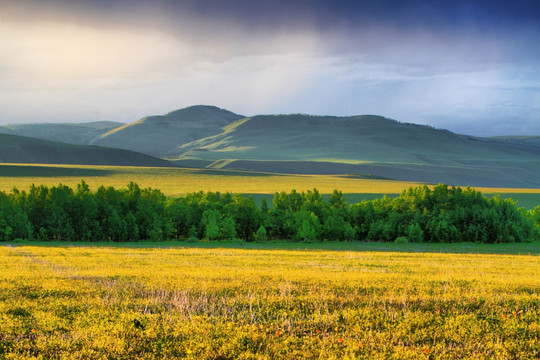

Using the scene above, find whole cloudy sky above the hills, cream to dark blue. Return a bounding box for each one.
[0,0,540,136]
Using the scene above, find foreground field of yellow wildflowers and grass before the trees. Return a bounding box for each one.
[0,243,540,359]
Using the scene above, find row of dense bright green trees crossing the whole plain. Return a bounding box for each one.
[0,181,540,243]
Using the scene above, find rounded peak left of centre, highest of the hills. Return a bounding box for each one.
[92,105,243,156]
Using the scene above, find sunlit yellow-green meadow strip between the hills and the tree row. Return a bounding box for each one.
[0,164,540,209]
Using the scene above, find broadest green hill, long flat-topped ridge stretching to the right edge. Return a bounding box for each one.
[171,114,540,187]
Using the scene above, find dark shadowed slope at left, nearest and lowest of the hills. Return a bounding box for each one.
[0,134,172,167]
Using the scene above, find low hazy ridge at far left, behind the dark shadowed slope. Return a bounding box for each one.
[0,121,125,145]
